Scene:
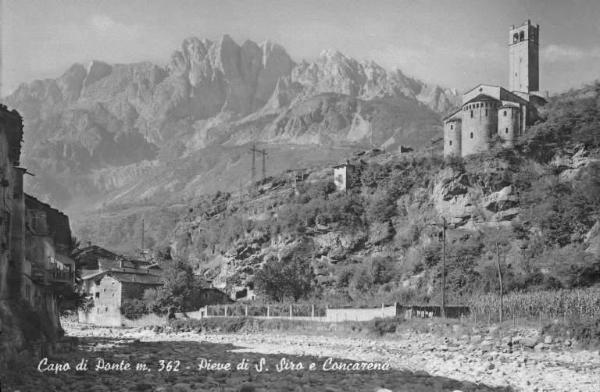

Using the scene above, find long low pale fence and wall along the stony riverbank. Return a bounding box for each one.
[195,303,469,322]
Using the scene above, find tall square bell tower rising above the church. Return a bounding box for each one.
[508,20,540,93]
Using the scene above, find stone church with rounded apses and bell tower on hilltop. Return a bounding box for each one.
[444,20,546,157]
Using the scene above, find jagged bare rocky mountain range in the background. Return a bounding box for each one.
[5,35,458,245]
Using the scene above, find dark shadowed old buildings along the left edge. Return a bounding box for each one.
[0,105,75,367]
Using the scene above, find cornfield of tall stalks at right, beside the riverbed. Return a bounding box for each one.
[469,288,600,321]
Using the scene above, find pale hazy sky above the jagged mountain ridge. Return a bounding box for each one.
[0,0,600,95]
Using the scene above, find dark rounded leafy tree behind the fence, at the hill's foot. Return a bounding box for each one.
[255,256,315,302]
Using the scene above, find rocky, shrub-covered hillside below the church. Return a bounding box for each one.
[82,84,600,302]
